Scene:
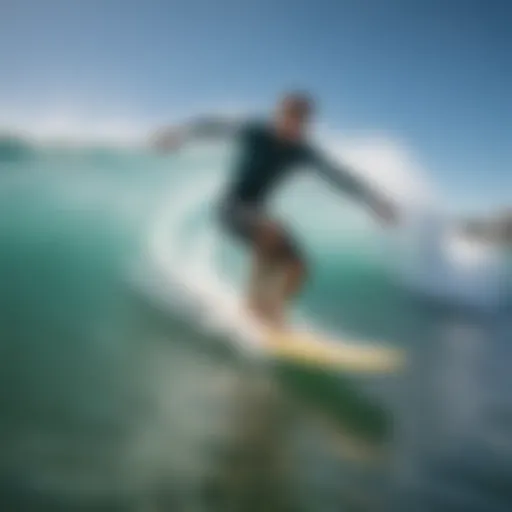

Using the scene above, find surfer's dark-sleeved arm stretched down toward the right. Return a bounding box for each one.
[310,152,396,226]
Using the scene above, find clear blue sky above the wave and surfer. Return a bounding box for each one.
[0,0,512,210]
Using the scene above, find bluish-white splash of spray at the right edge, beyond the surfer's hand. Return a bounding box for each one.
[395,205,510,311]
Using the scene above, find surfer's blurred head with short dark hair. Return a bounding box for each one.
[275,92,314,140]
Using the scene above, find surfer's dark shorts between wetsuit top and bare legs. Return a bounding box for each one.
[219,195,304,262]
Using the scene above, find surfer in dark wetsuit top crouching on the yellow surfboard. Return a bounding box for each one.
[214,93,395,326]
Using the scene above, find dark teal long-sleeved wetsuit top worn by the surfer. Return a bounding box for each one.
[222,123,368,209]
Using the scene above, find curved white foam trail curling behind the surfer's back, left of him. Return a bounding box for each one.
[142,168,268,349]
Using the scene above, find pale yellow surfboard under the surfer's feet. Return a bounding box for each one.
[265,330,405,373]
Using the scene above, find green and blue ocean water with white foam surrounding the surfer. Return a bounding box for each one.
[0,139,512,512]
